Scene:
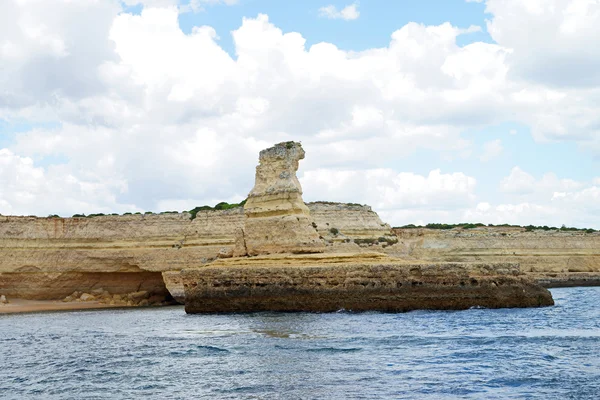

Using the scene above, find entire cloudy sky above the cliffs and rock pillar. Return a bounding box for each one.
[0,0,600,229]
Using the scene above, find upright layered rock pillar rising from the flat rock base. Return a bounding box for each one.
[234,142,325,256]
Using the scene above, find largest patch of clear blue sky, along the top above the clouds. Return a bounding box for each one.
[171,0,491,55]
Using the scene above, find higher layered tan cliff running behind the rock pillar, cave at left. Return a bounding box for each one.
[0,203,389,300]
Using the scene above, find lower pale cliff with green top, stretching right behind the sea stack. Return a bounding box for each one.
[385,227,600,286]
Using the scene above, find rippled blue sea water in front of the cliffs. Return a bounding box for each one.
[0,287,600,400]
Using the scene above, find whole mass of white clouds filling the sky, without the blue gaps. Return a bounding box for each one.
[0,0,600,231]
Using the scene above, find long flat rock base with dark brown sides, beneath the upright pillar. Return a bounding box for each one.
[182,253,554,313]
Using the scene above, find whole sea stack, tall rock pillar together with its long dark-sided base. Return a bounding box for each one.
[181,142,554,313]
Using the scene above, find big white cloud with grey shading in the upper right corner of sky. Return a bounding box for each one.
[486,0,600,148]
